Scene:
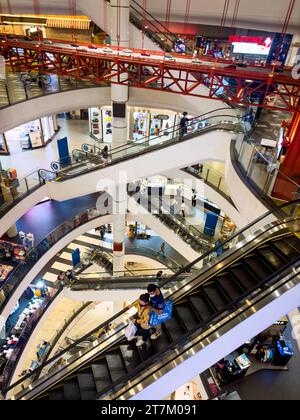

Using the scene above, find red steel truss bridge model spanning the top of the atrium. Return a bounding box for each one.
[0,35,300,113]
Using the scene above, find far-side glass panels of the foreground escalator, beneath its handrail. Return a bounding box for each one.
[5,200,300,395]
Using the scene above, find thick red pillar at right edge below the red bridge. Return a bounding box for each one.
[273,112,300,201]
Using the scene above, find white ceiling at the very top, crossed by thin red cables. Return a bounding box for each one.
[2,0,300,33]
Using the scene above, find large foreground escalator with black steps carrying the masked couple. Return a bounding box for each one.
[6,200,300,400]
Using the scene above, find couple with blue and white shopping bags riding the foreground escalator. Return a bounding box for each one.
[131,284,166,347]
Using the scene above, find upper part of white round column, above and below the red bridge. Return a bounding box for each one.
[110,0,130,148]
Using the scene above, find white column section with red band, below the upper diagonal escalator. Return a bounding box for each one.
[113,184,127,277]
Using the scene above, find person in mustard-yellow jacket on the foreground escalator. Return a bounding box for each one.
[132,293,151,347]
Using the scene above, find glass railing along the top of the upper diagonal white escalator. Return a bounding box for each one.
[0,108,243,217]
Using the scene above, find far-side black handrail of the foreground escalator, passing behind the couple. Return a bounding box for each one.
[6,199,300,392]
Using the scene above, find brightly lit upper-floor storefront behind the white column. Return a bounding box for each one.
[89,106,180,145]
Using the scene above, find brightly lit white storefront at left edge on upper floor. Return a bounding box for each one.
[0,115,58,155]
